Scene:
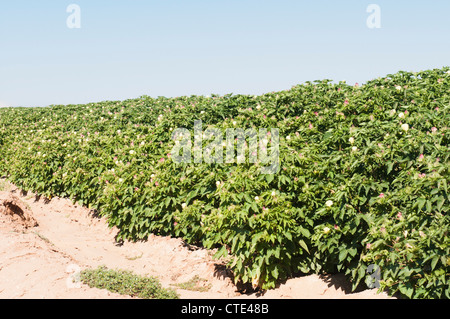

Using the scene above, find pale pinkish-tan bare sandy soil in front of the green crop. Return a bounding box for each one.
[0,180,389,299]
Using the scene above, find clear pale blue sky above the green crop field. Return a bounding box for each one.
[0,0,450,106]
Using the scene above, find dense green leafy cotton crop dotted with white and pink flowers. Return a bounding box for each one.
[0,68,450,298]
